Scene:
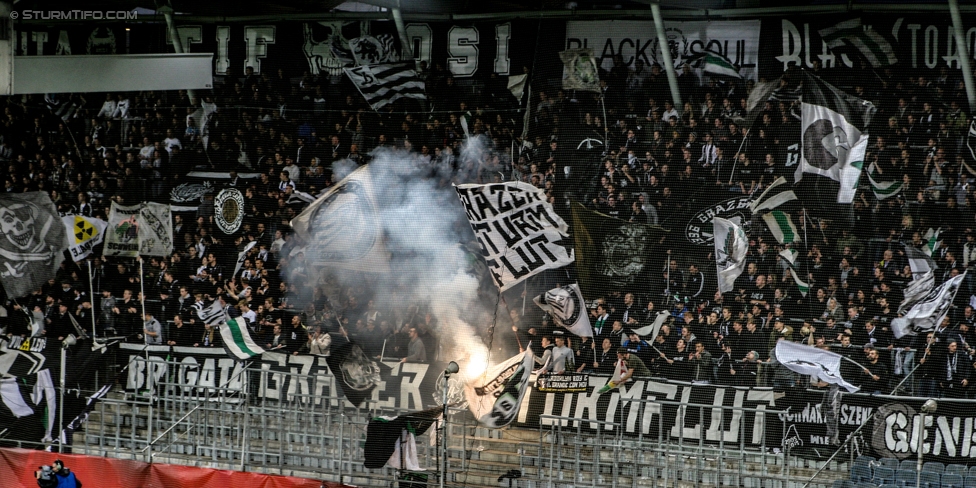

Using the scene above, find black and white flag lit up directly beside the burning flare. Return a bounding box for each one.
[464,344,534,429]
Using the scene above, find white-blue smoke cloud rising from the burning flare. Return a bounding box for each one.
[296,138,506,377]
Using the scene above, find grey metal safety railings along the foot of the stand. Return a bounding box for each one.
[7,361,900,488]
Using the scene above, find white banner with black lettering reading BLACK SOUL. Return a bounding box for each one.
[566,20,760,80]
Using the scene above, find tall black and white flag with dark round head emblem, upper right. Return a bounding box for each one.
[795,71,876,203]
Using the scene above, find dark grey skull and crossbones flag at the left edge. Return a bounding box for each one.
[0,191,68,298]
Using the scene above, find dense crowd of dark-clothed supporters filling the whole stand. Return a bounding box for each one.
[0,59,976,397]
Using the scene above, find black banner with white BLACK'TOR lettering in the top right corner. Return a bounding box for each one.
[759,14,976,77]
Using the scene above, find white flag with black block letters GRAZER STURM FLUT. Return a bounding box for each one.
[456,182,575,291]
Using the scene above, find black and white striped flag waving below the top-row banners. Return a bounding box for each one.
[343,62,427,110]
